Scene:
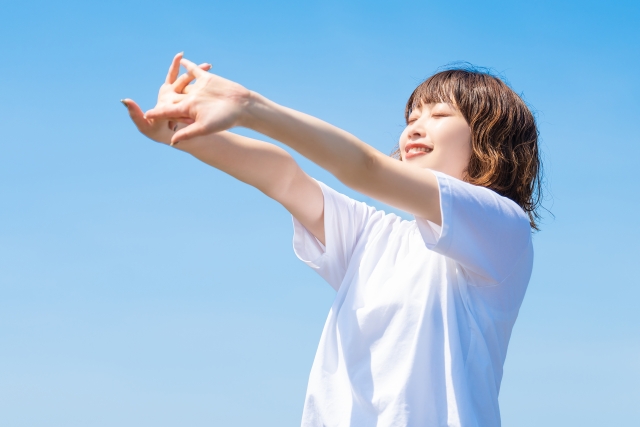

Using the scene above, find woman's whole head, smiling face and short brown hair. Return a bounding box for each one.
[400,66,542,229]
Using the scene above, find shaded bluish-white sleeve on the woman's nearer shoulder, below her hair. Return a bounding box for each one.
[416,171,531,284]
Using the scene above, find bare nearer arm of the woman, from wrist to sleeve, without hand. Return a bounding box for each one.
[243,92,441,224]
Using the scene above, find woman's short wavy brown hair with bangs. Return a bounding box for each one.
[392,68,542,230]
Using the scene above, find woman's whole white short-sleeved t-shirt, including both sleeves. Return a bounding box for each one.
[293,172,533,427]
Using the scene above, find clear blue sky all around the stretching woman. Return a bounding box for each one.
[0,0,640,427]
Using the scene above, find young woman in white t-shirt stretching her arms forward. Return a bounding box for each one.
[123,54,540,427]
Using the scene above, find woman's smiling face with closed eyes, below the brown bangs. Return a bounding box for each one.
[399,103,471,179]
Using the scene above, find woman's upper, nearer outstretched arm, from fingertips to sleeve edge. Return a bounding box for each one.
[147,59,441,224]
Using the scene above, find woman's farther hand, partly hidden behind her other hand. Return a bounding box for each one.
[122,53,211,145]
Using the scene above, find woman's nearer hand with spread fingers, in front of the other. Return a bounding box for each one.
[145,54,251,143]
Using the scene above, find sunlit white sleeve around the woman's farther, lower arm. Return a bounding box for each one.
[293,181,376,290]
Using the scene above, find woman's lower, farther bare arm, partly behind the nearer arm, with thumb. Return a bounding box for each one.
[123,99,325,244]
